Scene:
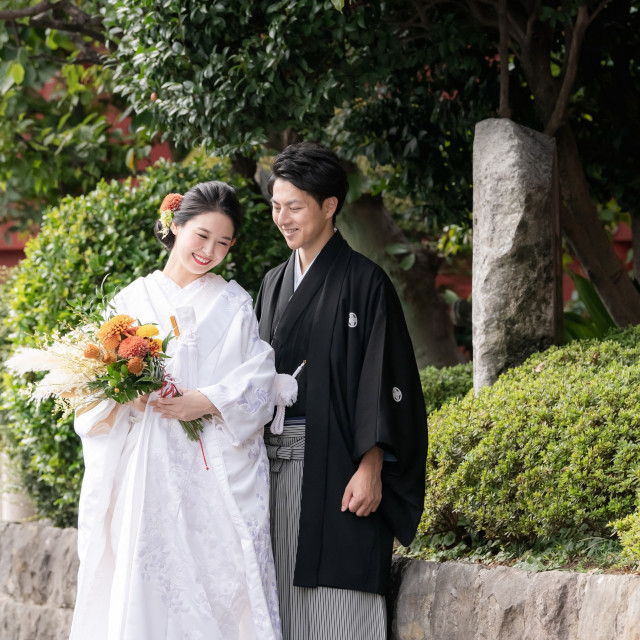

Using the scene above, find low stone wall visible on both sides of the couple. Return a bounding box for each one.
[0,522,640,640]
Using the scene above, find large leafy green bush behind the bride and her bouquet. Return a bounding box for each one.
[0,159,288,525]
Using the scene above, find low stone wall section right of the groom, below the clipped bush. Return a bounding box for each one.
[392,560,640,640]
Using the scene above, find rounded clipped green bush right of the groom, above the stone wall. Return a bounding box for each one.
[420,328,640,543]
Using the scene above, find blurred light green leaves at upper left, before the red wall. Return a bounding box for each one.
[0,10,149,226]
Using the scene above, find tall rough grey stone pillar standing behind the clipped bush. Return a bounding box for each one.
[473,118,562,393]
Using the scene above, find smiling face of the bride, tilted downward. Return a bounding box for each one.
[171,211,235,279]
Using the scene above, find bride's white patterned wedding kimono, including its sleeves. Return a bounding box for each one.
[71,271,281,640]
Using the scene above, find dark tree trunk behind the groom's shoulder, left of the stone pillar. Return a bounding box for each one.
[337,194,464,368]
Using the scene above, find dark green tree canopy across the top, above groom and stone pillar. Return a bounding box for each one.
[104,0,640,266]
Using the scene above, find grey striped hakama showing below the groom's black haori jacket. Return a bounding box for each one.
[265,417,387,640]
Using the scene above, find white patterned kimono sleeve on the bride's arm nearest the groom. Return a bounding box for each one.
[198,300,276,446]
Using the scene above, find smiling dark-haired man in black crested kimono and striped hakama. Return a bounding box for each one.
[256,143,427,640]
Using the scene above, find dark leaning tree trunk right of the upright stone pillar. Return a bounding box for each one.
[556,124,640,327]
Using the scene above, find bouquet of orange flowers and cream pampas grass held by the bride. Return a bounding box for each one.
[6,314,210,441]
